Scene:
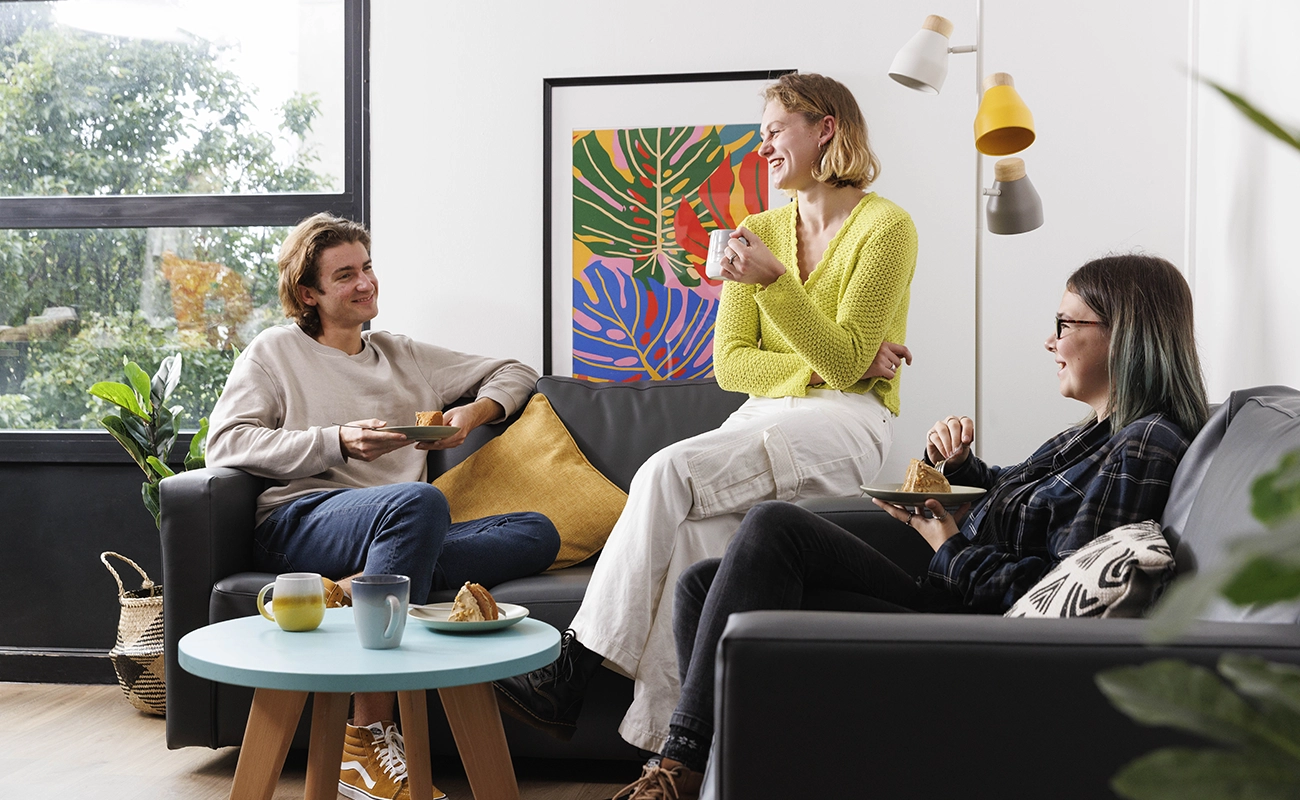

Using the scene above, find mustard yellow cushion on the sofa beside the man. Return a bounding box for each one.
[433,394,628,570]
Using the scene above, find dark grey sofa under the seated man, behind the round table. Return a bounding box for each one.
[161,377,745,760]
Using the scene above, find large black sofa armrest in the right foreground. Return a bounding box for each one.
[712,611,1300,799]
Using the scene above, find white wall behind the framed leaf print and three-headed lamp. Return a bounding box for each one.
[371,0,1188,481]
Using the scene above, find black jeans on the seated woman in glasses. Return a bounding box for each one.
[670,501,962,738]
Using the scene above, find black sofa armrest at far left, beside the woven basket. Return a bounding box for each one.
[159,467,265,749]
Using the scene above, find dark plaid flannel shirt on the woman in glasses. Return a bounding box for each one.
[930,414,1191,613]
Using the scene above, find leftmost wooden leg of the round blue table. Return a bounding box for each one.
[230,689,307,800]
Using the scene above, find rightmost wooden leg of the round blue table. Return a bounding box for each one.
[438,683,519,800]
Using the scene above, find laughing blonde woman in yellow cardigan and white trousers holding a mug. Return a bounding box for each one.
[497,74,917,752]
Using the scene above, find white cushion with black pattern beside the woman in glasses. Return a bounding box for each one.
[1006,520,1174,617]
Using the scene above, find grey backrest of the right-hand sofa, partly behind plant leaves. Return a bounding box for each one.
[1174,390,1300,622]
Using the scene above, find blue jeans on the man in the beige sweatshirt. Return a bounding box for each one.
[254,483,560,604]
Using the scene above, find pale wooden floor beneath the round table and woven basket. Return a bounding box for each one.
[0,683,640,800]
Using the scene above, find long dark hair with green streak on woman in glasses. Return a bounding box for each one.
[1066,255,1209,436]
